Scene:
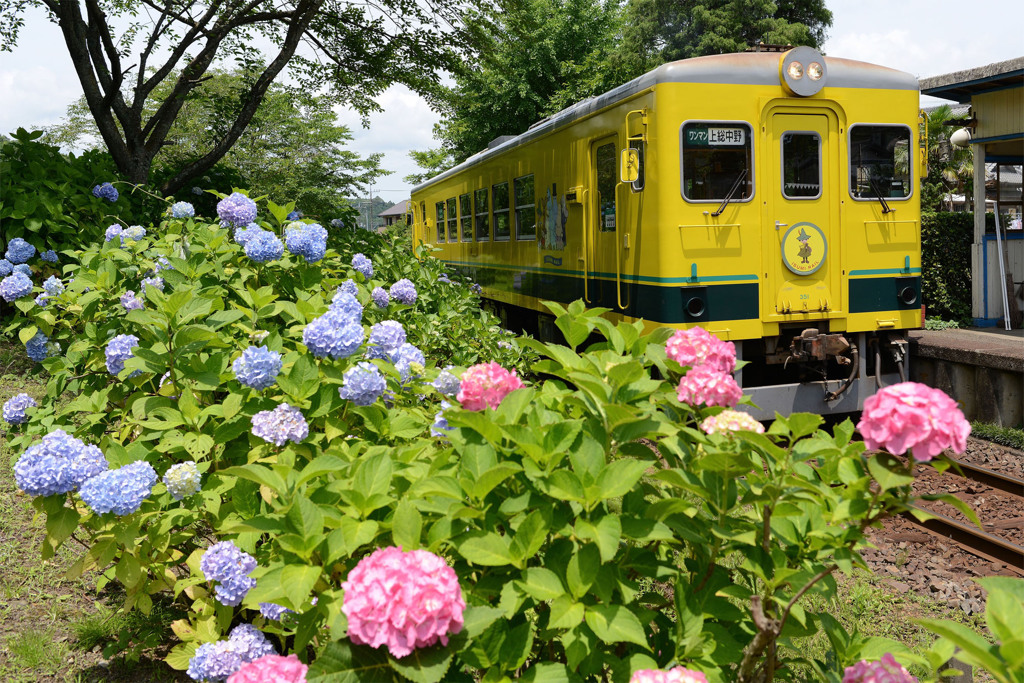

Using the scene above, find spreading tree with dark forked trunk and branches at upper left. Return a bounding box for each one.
[0,0,465,194]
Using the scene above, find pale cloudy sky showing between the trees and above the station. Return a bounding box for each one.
[0,0,1024,202]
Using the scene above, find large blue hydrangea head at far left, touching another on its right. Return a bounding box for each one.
[14,429,106,496]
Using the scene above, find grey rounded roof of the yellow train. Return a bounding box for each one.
[412,52,920,193]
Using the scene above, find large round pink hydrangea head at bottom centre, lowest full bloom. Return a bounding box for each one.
[341,547,466,657]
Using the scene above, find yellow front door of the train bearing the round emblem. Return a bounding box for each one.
[762,110,842,322]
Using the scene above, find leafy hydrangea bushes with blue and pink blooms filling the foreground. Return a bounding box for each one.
[0,187,995,683]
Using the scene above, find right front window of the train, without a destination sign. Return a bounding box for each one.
[850,124,912,200]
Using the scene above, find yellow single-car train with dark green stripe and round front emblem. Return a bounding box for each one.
[412,47,923,417]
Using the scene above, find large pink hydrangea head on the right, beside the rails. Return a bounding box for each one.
[857,382,971,462]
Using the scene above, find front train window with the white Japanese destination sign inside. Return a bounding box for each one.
[679,121,754,202]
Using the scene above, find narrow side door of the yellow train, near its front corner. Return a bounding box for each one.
[587,135,621,310]
